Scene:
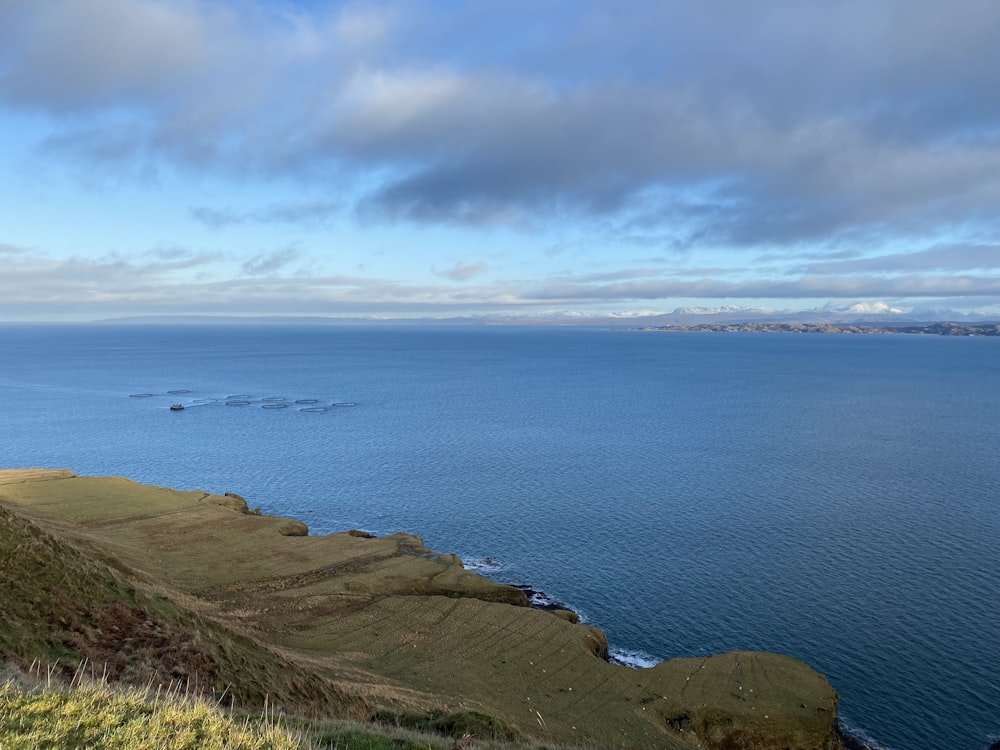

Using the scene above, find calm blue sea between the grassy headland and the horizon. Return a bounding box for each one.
[0,325,1000,750]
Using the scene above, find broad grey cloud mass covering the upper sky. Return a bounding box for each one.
[0,0,1000,251]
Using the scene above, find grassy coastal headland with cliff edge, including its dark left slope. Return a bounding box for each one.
[0,470,840,750]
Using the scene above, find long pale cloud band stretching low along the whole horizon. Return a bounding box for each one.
[0,246,1000,318]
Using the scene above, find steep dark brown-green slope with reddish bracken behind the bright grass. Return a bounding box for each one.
[0,494,371,717]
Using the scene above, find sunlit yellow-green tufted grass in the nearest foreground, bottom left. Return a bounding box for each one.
[0,664,538,750]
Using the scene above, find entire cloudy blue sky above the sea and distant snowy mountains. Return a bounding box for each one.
[0,0,1000,320]
